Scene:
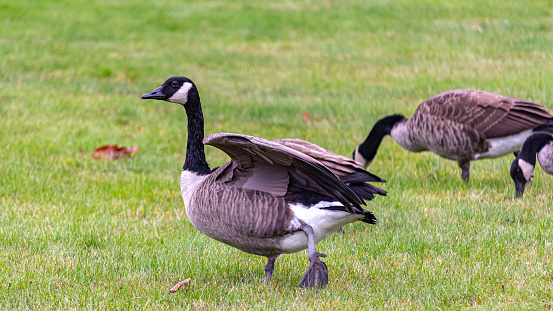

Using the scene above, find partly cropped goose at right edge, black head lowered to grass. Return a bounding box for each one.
[511,133,553,198]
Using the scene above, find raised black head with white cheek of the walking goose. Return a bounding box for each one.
[142,77,198,106]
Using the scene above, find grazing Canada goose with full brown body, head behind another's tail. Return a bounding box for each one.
[353,90,553,182]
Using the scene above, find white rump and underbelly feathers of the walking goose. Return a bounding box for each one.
[280,201,365,253]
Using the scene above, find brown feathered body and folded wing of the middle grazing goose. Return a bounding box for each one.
[406,90,553,160]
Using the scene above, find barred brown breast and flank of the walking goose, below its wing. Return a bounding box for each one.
[187,166,298,256]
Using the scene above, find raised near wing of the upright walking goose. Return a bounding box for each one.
[203,133,364,213]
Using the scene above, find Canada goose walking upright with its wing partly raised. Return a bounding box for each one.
[142,77,386,288]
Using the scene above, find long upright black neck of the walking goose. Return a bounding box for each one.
[182,90,211,175]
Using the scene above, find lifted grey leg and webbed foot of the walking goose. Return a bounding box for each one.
[299,225,328,288]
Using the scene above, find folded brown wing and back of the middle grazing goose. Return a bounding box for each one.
[415,90,553,138]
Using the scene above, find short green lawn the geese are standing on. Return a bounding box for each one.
[0,0,553,310]
